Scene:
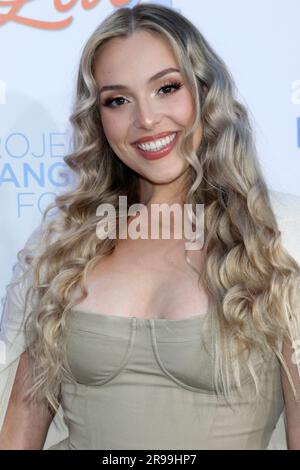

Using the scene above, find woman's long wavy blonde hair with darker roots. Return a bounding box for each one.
[18,4,300,410]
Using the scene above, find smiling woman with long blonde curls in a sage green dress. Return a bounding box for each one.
[0,4,300,449]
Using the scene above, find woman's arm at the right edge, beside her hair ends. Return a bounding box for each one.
[281,341,300,450]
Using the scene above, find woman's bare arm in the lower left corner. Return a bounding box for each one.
[0,351,54,450]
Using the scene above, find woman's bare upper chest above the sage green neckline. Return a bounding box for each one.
[76,240,208,319]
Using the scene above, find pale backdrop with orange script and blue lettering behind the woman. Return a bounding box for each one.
[0,0,300,450]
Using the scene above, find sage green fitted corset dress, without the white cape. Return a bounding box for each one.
[50,309,284,450]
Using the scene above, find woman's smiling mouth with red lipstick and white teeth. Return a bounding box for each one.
[133,132,179,160]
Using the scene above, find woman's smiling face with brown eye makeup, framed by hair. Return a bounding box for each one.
[95,31,202,195]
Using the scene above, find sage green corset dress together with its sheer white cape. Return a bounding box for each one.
[0,190,300,450]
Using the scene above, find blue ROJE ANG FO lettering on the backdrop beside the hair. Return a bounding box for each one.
[0,132,76,218]
